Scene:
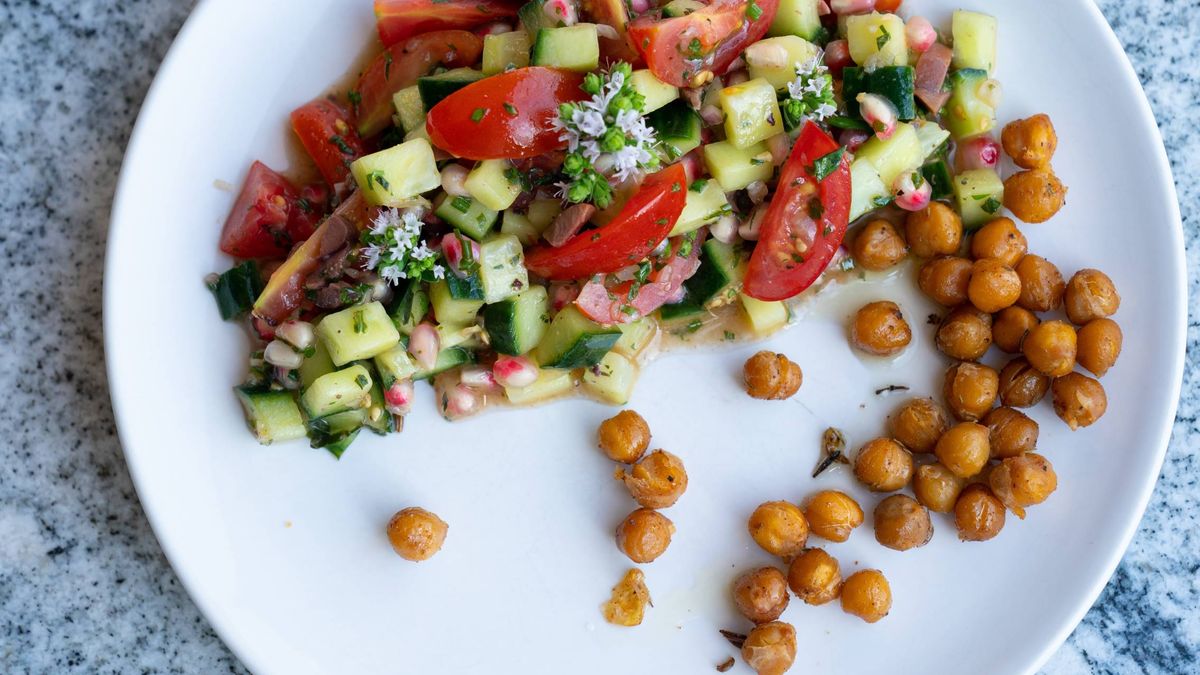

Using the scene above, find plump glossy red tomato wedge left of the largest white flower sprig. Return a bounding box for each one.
[425,67,588,160]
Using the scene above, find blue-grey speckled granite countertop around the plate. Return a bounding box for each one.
[0,0,1200,674]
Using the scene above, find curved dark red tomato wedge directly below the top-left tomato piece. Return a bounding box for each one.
[355,30,484,138]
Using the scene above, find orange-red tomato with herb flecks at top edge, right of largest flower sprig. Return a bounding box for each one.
[629,0,779,86]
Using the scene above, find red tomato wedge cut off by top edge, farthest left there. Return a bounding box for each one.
[374,0,521,47]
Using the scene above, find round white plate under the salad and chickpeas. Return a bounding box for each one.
[104,0,1184,674]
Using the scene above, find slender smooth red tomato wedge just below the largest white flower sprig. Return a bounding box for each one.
[526,165,688,280]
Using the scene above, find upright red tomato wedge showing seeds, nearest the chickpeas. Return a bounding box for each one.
[743,121,850,300]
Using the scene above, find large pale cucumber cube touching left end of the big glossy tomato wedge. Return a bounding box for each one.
[350,138,442,207]
